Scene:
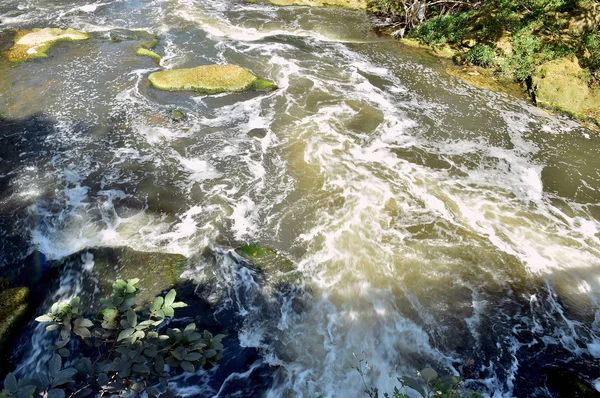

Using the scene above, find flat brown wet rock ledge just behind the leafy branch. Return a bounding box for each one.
[76,247,187,308]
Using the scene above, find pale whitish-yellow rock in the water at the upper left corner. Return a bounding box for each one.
[4,28,90,62]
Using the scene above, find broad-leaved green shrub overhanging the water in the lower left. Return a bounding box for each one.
[0,279,224,398]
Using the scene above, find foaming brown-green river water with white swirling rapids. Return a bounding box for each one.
[0,0,600,397]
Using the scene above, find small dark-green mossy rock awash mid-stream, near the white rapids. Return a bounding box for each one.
[235,243,300,286]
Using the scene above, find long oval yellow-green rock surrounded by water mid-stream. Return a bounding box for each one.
[148,65,277,94]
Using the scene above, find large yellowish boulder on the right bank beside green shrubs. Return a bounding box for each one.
[532,58,600,118]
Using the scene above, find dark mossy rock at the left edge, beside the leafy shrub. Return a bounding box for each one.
[0,287,29,352]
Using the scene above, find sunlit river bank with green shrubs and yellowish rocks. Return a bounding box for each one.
[368,0,600,124]
